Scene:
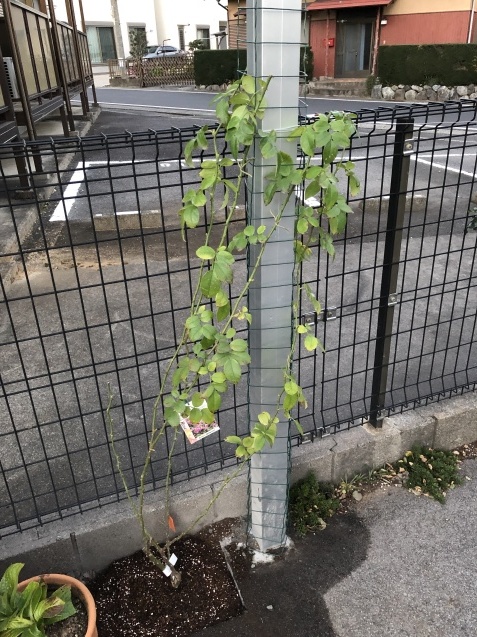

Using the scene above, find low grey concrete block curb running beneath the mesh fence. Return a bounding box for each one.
[0,392,477,577]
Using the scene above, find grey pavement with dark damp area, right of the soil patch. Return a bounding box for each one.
[194,454,477,637]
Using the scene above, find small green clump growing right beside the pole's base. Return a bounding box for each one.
[288,471,340,535]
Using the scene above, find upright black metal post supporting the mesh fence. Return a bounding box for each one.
[369,118,414,428]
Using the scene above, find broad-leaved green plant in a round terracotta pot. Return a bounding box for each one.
[0,563,98,637]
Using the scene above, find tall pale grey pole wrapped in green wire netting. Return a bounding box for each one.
[247,0,301,551]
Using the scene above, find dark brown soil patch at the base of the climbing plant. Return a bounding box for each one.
[89,537,242,637]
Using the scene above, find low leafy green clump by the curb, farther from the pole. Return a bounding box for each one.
[396,446,462,504]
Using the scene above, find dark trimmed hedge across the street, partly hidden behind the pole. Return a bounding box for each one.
[194,46,313,86]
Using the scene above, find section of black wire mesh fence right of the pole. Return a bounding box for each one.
[298,102,477,439]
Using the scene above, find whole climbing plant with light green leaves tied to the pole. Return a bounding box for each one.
[107,75,359,586]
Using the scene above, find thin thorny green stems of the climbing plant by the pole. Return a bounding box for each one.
[107,78,356,588]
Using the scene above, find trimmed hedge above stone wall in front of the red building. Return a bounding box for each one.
[378,44,477,86]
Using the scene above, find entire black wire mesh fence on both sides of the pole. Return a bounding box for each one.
[0,101,477,535]
